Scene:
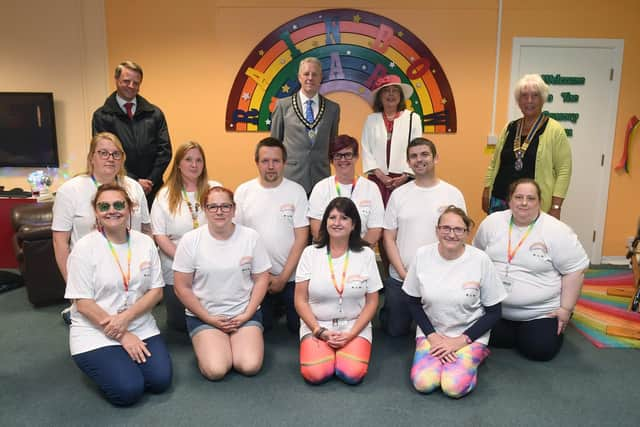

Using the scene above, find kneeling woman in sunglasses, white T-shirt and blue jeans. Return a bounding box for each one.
[65,184,171,406]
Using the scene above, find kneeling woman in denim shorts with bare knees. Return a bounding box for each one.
[173,187,271,380]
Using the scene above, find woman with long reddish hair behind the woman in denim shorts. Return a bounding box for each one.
[151,142,220,332]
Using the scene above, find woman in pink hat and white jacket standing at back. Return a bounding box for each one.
[361,75,422,206]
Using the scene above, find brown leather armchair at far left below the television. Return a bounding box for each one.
[11,202,65,307]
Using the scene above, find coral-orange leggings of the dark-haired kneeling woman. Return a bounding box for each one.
[300,335,371,384]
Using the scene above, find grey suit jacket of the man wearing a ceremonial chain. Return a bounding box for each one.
[271,93,340,194]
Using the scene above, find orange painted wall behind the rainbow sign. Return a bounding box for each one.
[105,0,640,256]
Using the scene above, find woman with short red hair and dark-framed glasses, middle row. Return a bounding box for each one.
[307,135,384,246]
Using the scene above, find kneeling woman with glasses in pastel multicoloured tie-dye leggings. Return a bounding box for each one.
[402,206,507,398]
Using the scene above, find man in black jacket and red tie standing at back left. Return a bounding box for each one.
[92,61,171,208]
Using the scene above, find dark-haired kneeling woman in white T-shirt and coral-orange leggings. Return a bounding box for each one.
[295,197,382,384]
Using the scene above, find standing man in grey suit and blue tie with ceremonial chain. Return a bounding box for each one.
[271,57,340,194]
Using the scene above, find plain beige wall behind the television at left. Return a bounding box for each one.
[0,0,109,188]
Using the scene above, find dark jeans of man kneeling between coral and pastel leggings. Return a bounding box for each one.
[380,277,413,337]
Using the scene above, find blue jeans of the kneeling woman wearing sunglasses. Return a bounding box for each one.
[72,335,172,406]
